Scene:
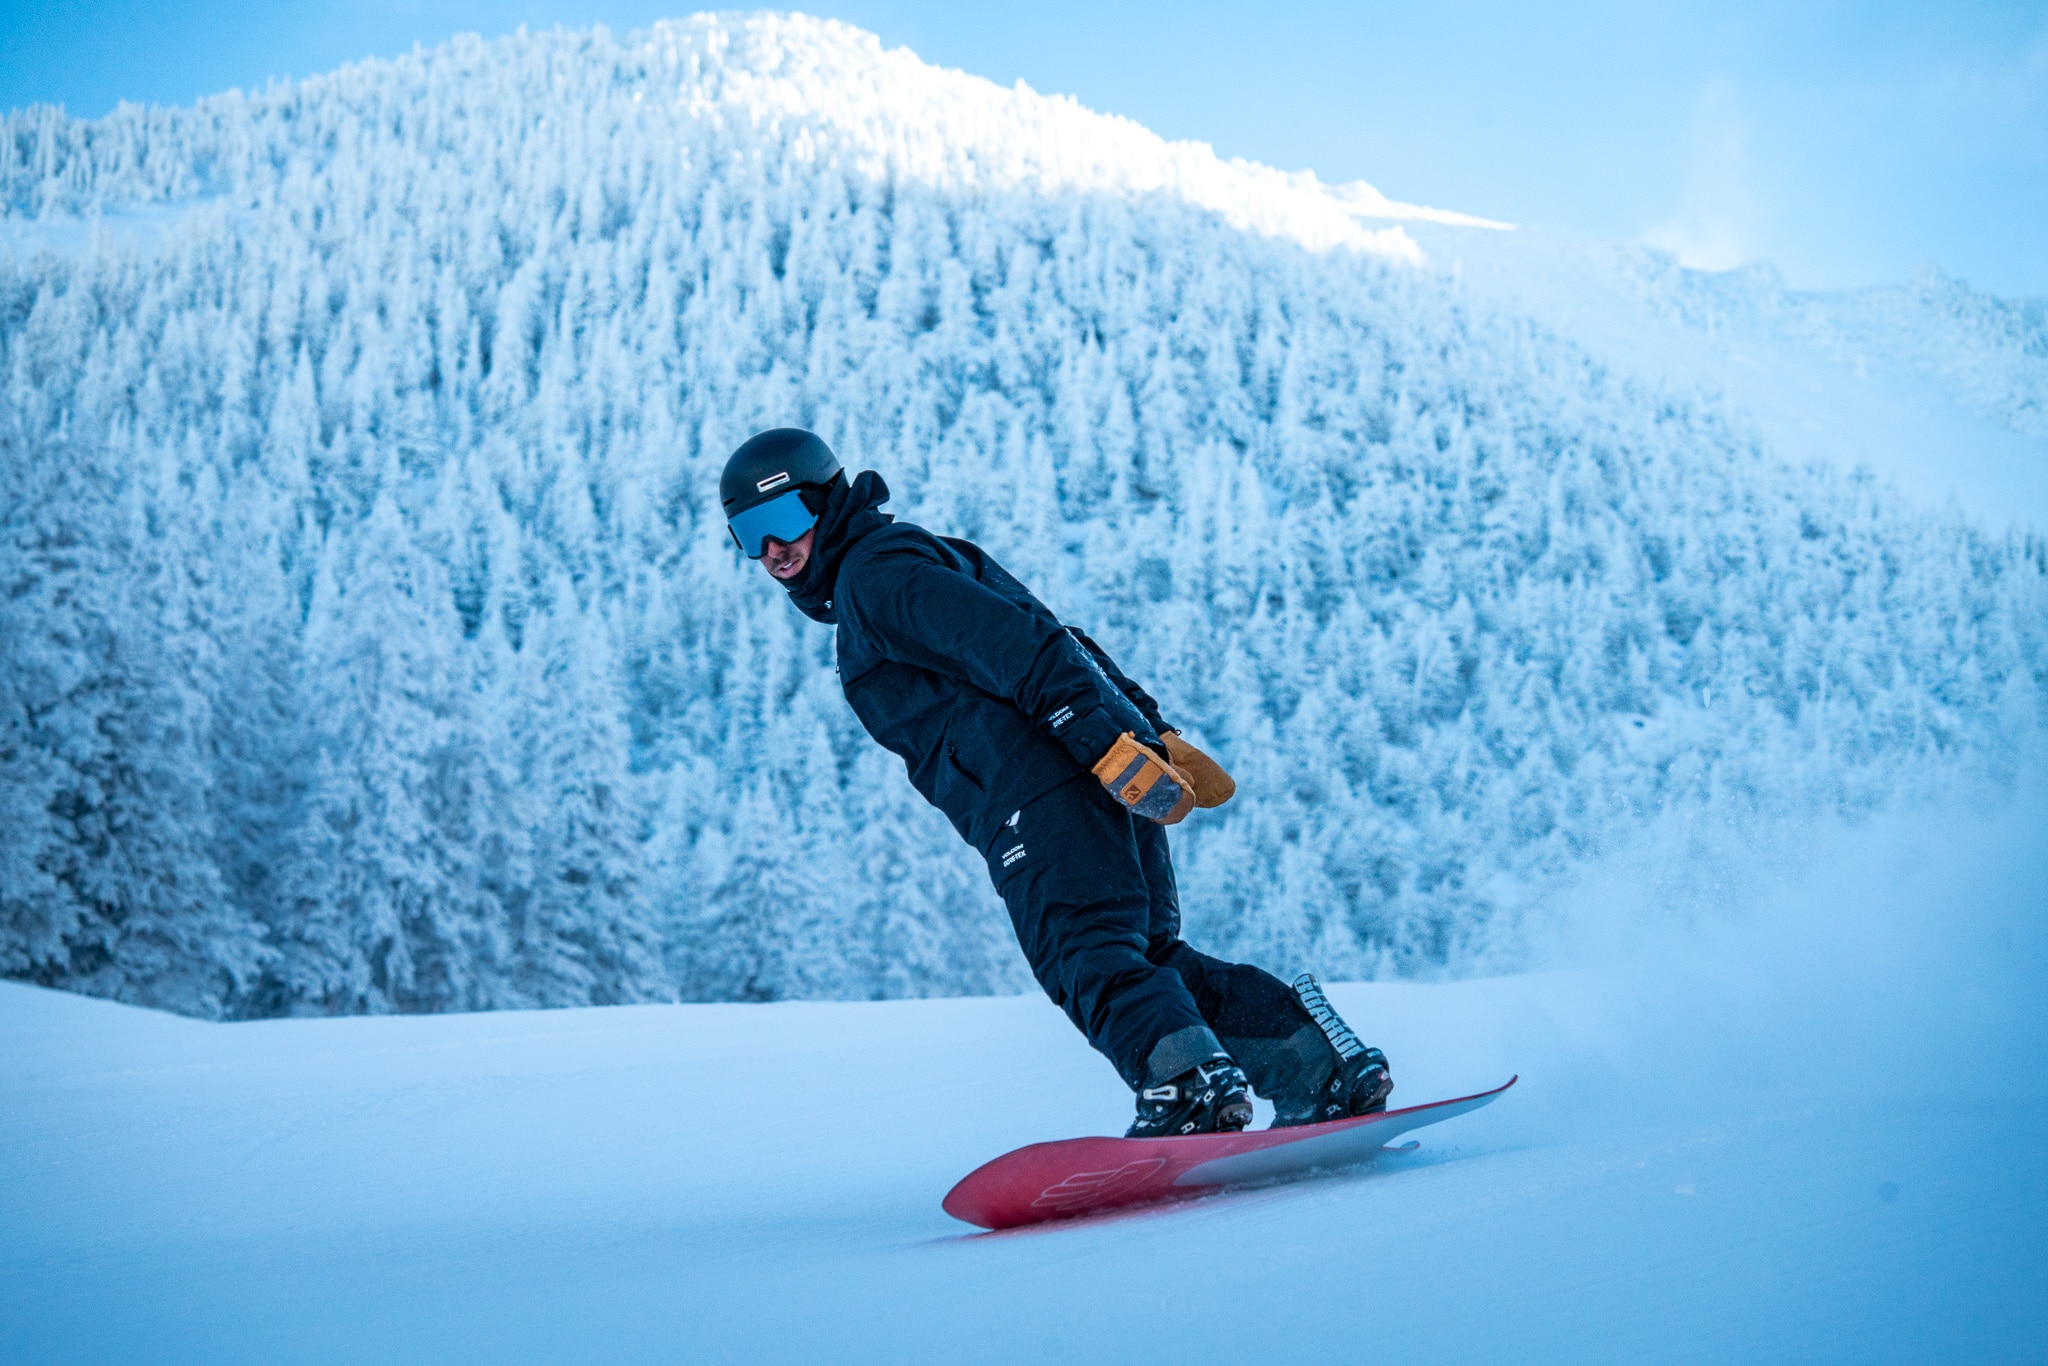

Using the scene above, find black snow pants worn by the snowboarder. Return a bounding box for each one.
[987,774,1335,1098]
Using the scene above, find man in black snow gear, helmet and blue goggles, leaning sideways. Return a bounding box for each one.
[719,428,1393,1139]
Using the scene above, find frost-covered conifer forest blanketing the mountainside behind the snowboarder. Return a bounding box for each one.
[0,16,2048,1016]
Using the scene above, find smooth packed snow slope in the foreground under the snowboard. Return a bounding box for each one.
[0,794,2048,1366]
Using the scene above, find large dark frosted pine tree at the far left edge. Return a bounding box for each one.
[0,428,264,1016]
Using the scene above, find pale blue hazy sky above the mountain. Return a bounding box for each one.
[12,0,2048,295]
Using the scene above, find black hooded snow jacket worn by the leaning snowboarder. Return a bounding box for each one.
[784,471,1165,852]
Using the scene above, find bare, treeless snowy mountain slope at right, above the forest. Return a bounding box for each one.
[1417,225,2048,530]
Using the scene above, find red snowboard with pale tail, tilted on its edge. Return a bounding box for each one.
[944,1077,1518,1229]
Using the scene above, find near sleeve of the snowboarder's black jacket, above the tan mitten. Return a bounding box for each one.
[840,549,1161,768]
